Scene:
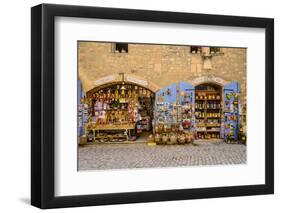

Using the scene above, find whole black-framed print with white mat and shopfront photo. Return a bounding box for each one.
[31,4,274,208]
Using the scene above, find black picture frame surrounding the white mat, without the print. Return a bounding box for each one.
[31,4,274,209]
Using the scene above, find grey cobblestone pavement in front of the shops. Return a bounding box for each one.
[78,142,246,170]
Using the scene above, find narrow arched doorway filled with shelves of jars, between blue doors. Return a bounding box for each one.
[195,83,223,140]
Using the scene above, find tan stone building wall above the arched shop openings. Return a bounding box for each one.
[78,41,247,104]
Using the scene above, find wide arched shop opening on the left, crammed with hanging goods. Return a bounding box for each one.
[86,82,155,142]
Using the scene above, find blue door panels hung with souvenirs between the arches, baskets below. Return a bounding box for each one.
[154,82,194,144]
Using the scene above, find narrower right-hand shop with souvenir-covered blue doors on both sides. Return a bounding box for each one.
[154,82,241,144]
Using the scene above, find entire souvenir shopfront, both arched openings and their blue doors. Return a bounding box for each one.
[78,77,243,144]
